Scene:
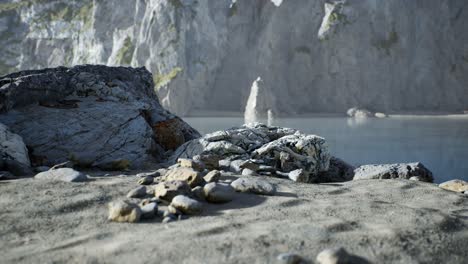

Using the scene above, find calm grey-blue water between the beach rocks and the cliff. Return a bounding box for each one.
[184,117,468,182]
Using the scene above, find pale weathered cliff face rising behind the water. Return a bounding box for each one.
[0,0,468,115]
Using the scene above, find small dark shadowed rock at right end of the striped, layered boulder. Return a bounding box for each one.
[311,157,356,183]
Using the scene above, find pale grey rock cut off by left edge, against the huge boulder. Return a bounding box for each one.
[0,123,31,169]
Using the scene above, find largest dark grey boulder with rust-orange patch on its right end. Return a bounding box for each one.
[0,65,199,170]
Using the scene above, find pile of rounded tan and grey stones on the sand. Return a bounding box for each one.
[109,158,276,223]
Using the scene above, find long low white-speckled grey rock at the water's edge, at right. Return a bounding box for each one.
[353,162,434,182]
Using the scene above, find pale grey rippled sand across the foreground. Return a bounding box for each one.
[0,176,468,264]
